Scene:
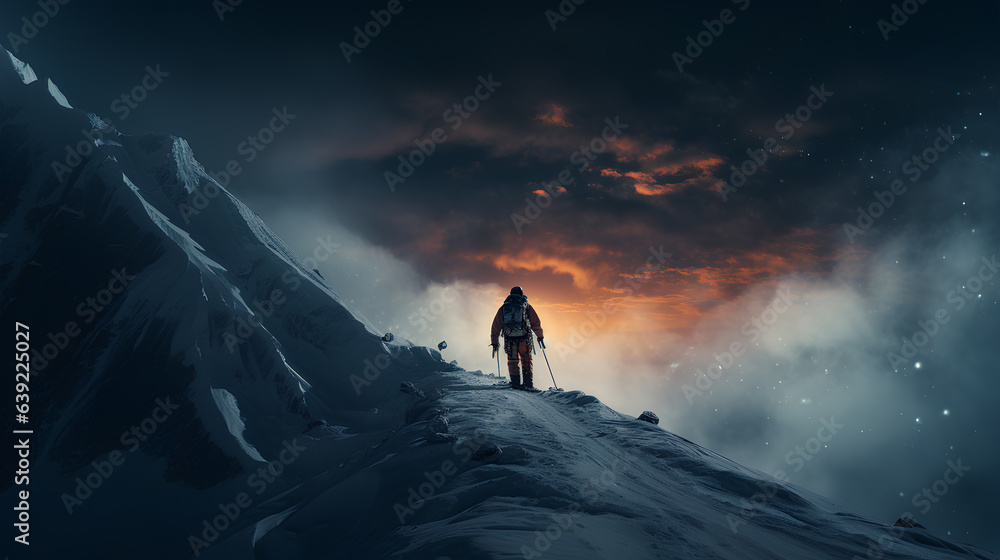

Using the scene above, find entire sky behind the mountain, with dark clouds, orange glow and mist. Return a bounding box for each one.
[0,0,1000,551]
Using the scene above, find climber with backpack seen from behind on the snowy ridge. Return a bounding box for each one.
[490,286,543,390]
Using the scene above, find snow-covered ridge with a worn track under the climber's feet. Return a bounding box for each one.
[205,372,997,560]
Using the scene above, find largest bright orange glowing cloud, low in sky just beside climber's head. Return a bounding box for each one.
[402,211,852,340]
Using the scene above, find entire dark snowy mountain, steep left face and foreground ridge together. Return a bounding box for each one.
[0,49,998,560]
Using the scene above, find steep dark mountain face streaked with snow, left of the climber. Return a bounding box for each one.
[0,53,451,556]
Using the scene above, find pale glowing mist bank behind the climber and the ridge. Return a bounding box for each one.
[244,154,1000,548]
